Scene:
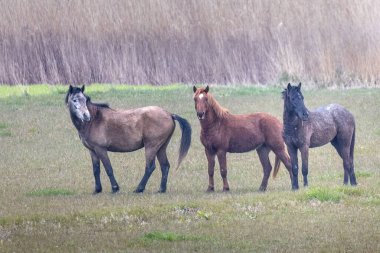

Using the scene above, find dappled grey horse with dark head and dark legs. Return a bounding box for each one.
[282,83,356,190]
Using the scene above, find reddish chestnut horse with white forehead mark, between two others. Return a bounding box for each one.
[193,86,292,191]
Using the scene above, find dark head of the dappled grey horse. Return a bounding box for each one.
[282,83,309,121]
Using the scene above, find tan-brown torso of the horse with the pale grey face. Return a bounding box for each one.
[91,106,174,152]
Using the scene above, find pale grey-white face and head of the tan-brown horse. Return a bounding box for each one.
[66,85,91,122]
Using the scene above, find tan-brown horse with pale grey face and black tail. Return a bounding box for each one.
[66,85,191,193]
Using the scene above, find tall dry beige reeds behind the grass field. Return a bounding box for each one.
[0,0,380,85]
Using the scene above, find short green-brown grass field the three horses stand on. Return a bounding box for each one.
[0,85,380,252]
